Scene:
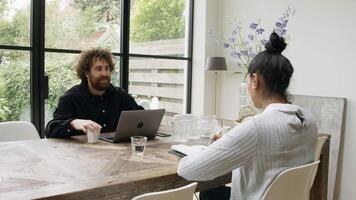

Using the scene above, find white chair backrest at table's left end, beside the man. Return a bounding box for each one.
[0,121,40,142]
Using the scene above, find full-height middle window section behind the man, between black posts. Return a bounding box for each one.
[44,0,121,124]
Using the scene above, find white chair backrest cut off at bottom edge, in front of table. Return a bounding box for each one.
[133,182,198,200]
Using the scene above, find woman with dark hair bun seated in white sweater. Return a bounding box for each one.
[178,32,317,200]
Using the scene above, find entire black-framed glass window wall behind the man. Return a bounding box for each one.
[0,0,193,136]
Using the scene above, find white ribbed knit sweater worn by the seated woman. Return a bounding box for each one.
[178,104,317,200]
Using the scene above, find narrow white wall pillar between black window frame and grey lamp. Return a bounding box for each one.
[192,0,225,115]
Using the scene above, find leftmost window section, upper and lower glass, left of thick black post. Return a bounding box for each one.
[0,0,31,121]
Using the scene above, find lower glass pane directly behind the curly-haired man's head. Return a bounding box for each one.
[45,53,120,124]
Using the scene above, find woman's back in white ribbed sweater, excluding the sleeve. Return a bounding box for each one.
[231,104,317,199]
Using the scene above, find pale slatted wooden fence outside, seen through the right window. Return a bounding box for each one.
[129,39,187,120]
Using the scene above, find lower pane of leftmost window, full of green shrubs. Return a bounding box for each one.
[0,50,31,121]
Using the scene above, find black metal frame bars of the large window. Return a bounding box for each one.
[0,0,194,138]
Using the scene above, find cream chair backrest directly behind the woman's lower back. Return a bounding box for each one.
[262,161,320,200]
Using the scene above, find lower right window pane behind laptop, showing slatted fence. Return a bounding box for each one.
[129,58,187,124]
